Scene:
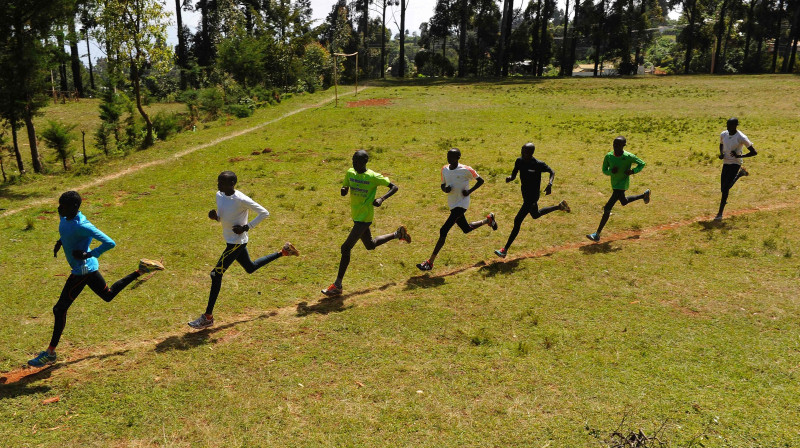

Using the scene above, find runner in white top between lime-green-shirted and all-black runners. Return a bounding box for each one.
[417,148,497,271]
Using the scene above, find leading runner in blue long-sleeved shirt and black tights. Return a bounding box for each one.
[28,191,164,367]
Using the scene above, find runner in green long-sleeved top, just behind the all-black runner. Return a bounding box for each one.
[586,136,650,242]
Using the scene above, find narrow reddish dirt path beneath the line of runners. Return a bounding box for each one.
[0,203,800,390]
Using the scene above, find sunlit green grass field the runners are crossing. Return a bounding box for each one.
[0,76,800,447]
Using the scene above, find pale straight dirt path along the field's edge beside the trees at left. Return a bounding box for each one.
[0,87,369,218]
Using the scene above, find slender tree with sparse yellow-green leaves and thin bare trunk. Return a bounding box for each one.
[103,0,172,147]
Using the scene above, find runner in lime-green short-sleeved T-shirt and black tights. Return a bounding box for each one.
[322,150,411,297]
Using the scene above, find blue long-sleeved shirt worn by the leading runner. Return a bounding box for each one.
[58,212,117,275]
